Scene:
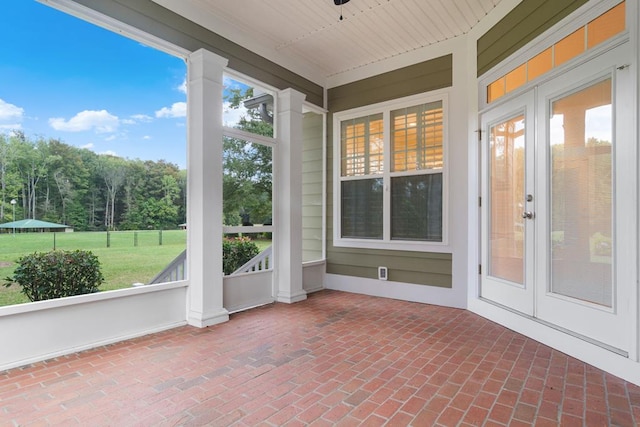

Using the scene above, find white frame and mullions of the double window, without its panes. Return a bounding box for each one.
[333,89,450,252]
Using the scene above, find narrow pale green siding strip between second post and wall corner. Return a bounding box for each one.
[302,113,324,261]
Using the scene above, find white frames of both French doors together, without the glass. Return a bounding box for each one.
[479,44,638,357]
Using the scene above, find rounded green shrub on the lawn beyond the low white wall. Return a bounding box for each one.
[5,250,104,301]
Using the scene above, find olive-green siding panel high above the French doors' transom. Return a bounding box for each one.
[478,0,587,76]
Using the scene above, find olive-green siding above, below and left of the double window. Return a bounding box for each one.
[327,55,453,288]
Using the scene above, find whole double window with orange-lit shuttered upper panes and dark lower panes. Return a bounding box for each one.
[334,96,446,247]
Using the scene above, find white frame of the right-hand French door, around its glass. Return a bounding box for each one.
[536,43,638,354]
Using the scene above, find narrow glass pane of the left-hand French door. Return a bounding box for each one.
[489,115,525,284]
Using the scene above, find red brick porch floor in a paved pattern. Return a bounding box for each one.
[0,291,640,426]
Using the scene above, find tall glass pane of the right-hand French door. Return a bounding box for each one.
[549,79,613,307]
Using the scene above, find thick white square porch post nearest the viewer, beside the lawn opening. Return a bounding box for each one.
[187,49,229,328]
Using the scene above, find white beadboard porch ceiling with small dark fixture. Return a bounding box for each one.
[153,0,502,86]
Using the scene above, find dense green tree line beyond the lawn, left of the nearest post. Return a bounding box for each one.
[0,131,187,231]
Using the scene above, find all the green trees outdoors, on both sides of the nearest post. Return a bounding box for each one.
[0,88,273,231]
